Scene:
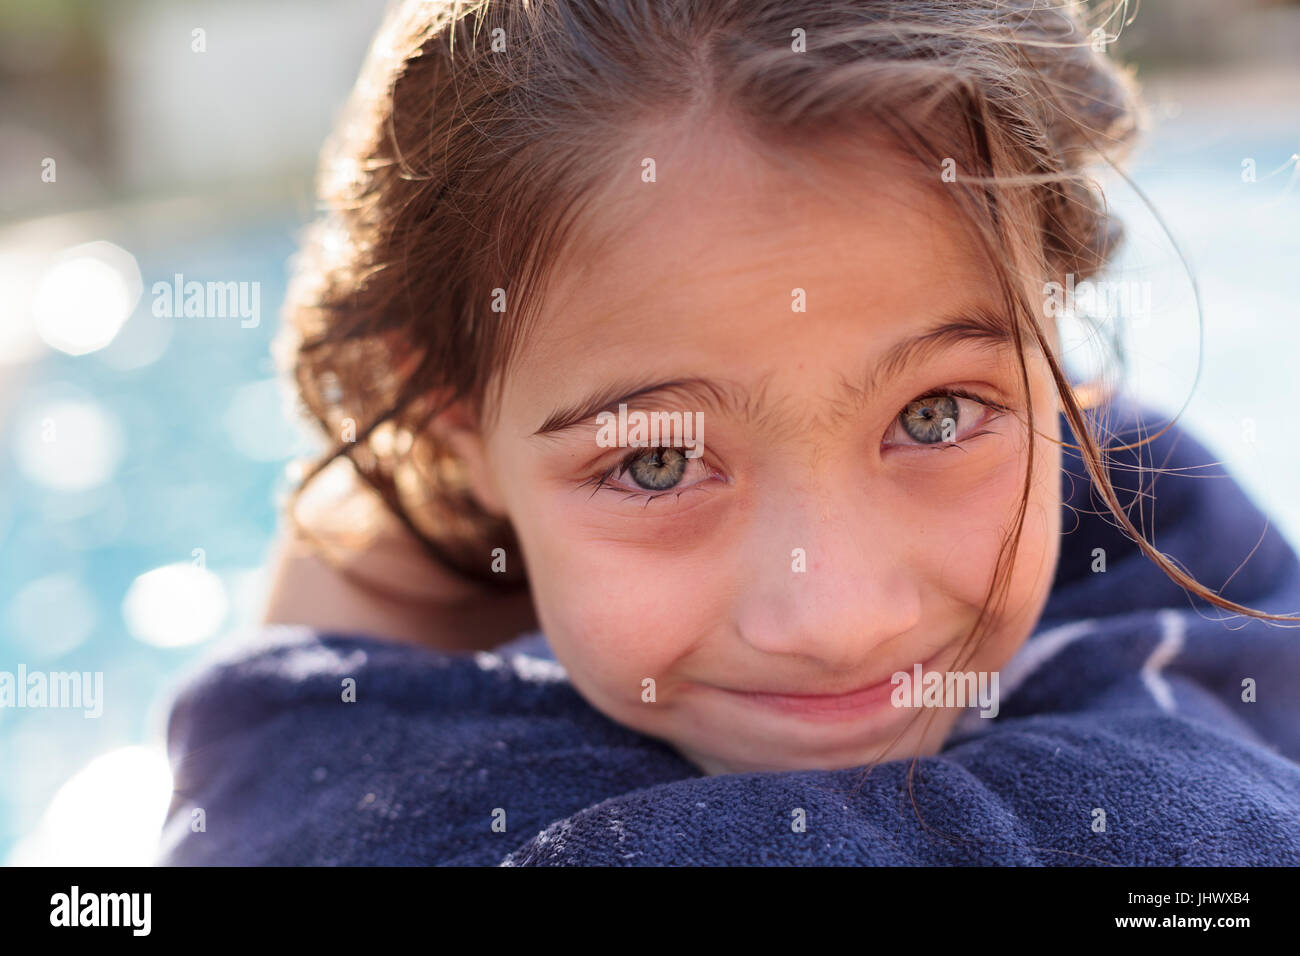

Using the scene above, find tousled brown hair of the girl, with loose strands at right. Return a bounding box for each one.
[281,0,1295,648]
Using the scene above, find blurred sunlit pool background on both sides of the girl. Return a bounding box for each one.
[0,0,1300,865]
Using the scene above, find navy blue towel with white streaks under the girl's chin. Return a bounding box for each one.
[161,406,1300,865]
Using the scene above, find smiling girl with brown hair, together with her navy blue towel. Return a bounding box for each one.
[165,0,1300,864]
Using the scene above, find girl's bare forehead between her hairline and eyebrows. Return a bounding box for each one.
[508,124,997,418]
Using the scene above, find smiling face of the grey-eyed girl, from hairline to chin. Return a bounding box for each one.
[462,127,1061,773]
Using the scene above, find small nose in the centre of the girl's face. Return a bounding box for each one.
[735,468,922,678]
